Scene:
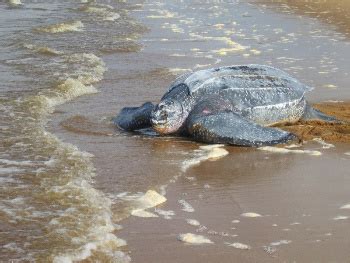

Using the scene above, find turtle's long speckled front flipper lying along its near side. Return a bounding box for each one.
[187,111,297,146]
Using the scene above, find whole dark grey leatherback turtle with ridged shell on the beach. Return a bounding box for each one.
[114,65,336,146]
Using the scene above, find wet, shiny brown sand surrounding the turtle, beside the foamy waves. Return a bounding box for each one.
[43,1,350,262]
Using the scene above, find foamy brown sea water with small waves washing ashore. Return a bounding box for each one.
[0,1,145,262]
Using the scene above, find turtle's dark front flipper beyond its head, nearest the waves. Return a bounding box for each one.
[113,102,154,131]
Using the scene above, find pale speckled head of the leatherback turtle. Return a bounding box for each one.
[151,100,186,134]
